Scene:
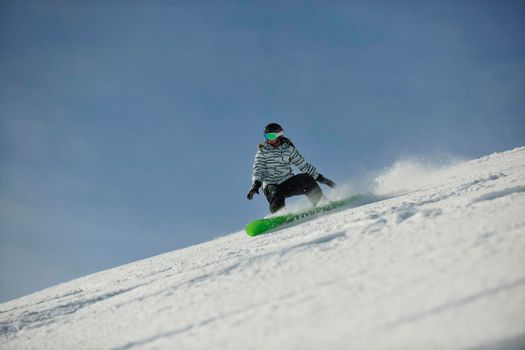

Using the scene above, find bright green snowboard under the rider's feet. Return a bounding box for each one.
[244,195,362,237]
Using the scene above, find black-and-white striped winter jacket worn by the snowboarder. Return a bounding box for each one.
[252,138,319,188]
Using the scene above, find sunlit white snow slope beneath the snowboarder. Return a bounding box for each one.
[0,147,525,349]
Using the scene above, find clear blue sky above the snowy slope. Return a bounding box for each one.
[0,1,525,301]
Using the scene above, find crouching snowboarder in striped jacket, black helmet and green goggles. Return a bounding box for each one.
[247,123,335,213]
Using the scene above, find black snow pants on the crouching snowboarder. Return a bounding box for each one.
[264,174,323,213]
